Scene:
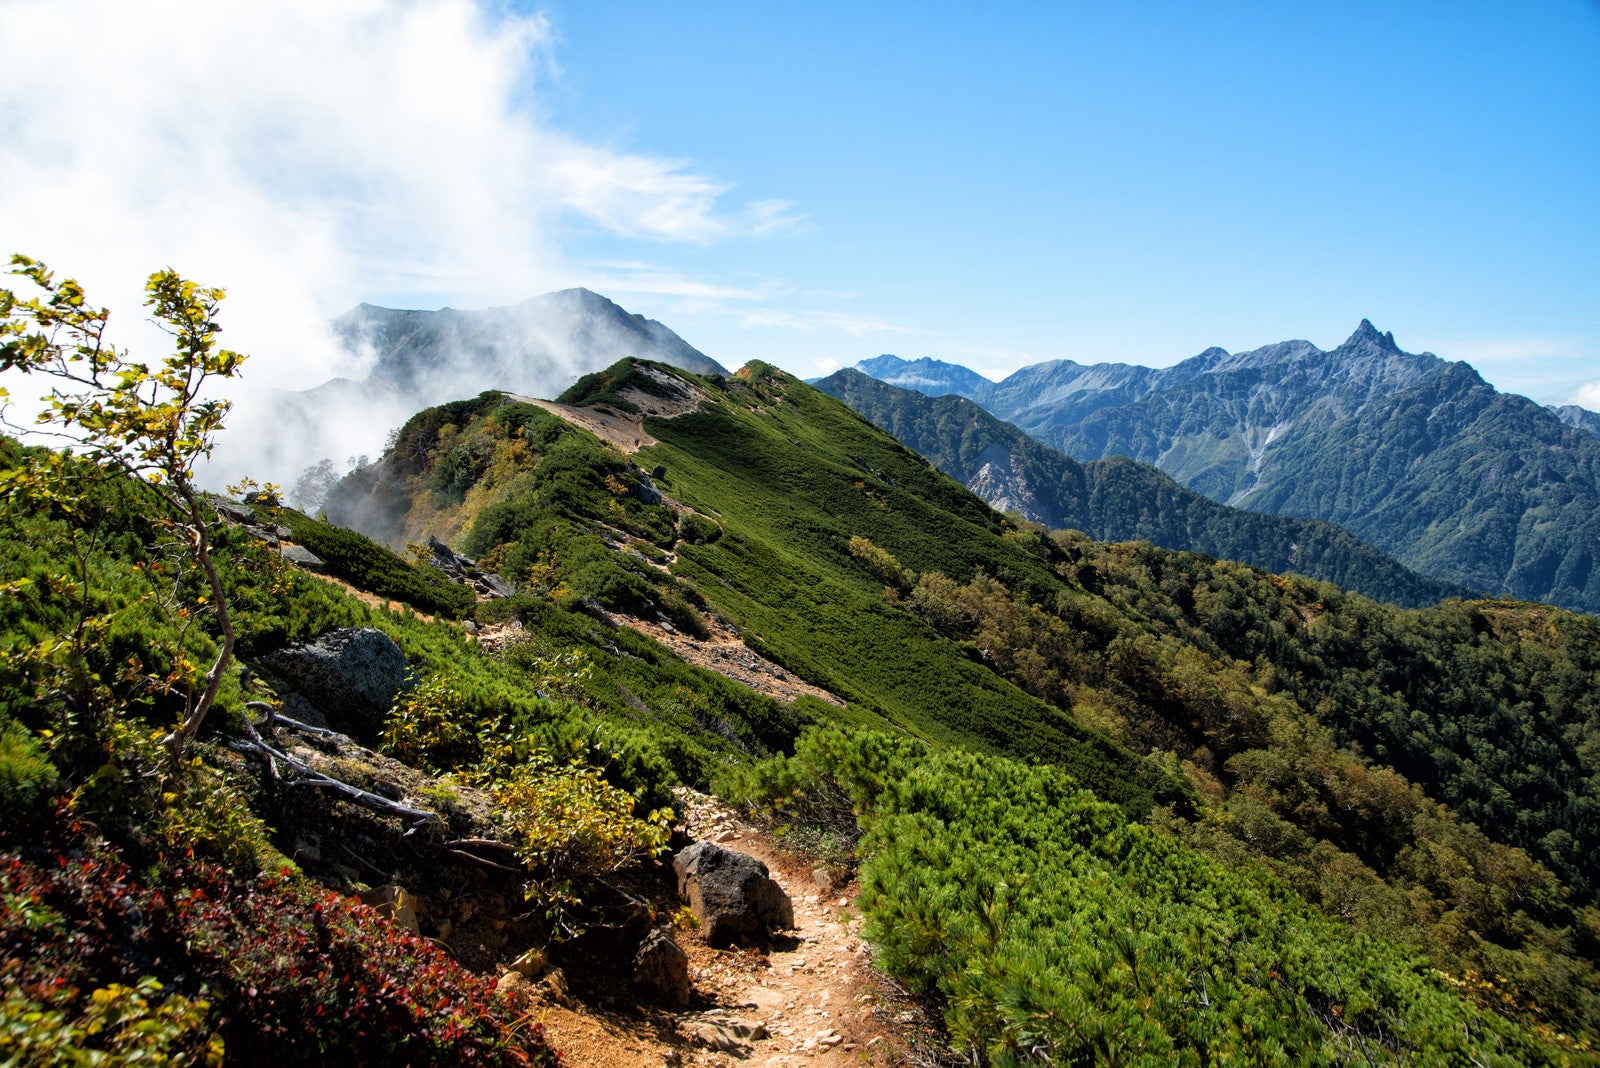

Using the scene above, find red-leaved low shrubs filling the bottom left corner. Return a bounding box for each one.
[0,817,560,1065]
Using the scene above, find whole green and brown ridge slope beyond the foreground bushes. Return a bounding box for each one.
[330,363,1600,920]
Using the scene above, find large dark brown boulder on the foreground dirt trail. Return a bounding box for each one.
[672,841,795,945]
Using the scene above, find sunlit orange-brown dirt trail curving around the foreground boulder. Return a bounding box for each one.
[534,795,920,1068]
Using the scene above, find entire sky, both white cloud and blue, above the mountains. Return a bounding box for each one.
[0,0,1600,408]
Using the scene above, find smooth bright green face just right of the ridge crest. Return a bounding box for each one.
[588,365,1178,809]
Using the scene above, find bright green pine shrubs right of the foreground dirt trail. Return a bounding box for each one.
[734,729,1589,1065]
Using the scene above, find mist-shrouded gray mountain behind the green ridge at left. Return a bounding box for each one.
[216,289,726,495]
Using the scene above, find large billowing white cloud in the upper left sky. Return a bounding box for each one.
[0,0,786,489]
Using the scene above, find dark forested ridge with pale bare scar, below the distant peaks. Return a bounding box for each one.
[816,364,1466,606]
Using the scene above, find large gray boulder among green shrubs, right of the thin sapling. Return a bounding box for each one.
[258,627,410,735]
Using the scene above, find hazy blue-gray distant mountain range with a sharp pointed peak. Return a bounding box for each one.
[858,320,1600,612]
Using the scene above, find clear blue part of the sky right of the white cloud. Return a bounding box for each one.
[546,2,1600,401]
